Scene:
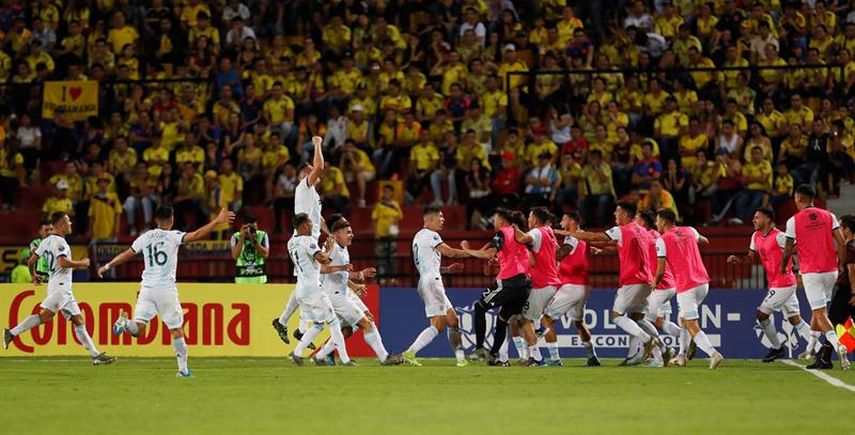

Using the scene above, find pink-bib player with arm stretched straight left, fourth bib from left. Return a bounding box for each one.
[572,201,661,364]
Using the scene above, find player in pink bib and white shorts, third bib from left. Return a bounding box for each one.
[541,211,600,367]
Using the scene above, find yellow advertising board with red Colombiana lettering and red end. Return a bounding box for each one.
[0,282,380,358]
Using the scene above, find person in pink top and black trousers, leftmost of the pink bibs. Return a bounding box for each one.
[461,208,532,366]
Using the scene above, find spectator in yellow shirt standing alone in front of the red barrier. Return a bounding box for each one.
[371,184,404,278]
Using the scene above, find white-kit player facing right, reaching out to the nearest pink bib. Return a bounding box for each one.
[394,204,478,367]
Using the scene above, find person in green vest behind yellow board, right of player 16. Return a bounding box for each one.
[231,216,270,284]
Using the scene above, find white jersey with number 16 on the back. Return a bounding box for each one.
[131,228,186,289]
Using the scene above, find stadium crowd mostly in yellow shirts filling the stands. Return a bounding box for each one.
[0,0,855,239]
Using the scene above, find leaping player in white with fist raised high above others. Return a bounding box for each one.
[271,136,329,349]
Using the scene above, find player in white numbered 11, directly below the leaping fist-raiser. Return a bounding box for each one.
[288,213,354,366]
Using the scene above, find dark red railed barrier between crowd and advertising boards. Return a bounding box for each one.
[90,239,765,289]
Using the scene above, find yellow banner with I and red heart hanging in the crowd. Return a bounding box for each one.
[42,81,98,121]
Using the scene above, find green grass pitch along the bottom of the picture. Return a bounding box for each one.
[0,356,855,434]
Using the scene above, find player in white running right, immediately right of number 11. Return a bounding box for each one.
[314,218,399,365]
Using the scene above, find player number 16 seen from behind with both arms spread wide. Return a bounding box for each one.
[98,204,235,378]
